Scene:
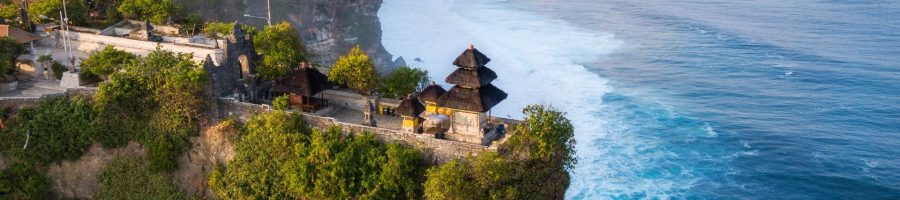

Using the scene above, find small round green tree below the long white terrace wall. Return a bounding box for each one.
[81,46,137,78]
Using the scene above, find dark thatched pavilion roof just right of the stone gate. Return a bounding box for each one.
[272,63,328,96]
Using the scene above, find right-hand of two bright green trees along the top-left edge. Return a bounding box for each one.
[117,0,180,24]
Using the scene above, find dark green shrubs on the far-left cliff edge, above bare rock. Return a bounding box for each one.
[0,97,95,163]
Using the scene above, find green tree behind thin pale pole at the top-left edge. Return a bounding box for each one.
[28,0,87,25]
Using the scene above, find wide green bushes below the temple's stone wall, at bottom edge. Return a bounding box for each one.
[209,111,424,199]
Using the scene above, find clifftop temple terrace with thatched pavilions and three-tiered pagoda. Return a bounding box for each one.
[271,45,517,146]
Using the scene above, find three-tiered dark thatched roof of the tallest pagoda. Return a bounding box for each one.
[438,45,507,112]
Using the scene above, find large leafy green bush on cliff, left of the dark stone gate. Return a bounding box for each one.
[95,47,207,171]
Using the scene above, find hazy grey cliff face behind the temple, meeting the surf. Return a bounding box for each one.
[189,0,396,73]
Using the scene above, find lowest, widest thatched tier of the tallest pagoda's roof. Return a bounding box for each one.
[438,84,507,112]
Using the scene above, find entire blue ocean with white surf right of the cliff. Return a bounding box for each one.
[378,0,900,199]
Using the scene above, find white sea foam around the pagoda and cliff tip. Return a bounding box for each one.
[379,0,694,199]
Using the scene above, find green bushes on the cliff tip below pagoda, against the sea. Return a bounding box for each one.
[425,106,576,199]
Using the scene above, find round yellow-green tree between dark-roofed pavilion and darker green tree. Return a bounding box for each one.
[328,46,379,94]
